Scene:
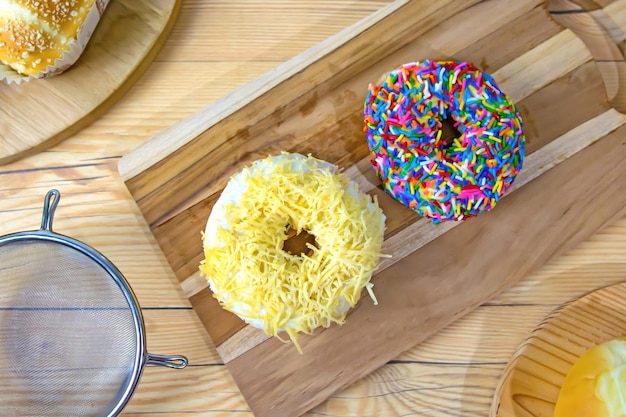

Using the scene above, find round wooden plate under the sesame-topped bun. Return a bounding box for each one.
[0,0,181,164]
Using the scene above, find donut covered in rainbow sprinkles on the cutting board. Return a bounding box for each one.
[364,60,525,223]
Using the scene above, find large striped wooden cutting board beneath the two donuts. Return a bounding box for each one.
[119,0,626,417]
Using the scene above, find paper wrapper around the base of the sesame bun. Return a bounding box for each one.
[0,0,110,84]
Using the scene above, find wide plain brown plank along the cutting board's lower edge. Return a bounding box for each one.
[228,122,626,415]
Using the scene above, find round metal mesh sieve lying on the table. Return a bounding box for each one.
[0,190,187,417]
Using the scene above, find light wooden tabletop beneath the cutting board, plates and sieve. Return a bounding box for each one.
[0,0,626,417]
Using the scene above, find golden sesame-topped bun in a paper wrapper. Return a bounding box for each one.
[0,0,95,75]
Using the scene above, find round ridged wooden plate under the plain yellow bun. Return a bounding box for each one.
[489,283,626,417]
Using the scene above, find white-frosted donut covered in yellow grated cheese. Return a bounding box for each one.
[200,153,385,352]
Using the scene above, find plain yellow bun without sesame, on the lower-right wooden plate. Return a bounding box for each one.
[554,338,626,417]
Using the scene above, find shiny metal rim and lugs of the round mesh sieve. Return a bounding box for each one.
[0,189,188,417]
